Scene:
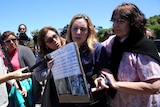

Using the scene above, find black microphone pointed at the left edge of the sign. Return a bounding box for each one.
[28,54,52,72]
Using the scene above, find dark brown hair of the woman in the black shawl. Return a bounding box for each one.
[111,3,146,35]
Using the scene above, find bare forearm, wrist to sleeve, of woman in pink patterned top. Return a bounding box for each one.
[113,80,160,95]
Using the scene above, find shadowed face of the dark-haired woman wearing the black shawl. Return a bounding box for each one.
[112,15,130,38]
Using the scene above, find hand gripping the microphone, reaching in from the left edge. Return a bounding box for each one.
[12,67,32,80]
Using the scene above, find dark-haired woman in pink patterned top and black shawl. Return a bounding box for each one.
[95,3,160,107]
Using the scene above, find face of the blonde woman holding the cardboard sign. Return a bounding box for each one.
[71,18,88,47]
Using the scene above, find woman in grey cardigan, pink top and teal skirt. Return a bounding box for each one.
[1,31,36,107]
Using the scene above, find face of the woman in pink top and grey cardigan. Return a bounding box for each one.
[4,35,18,53]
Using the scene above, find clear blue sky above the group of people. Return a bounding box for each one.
[0,0,160,37]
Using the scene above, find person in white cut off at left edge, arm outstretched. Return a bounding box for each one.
[0,57,31,107]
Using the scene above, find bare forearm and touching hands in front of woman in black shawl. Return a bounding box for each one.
[95,70,160,95]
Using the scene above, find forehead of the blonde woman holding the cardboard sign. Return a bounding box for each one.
[72,18,87,27]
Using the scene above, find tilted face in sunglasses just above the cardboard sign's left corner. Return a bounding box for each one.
[44,30,61,50]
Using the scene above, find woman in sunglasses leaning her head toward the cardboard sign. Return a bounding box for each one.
[34,26,66,107]
